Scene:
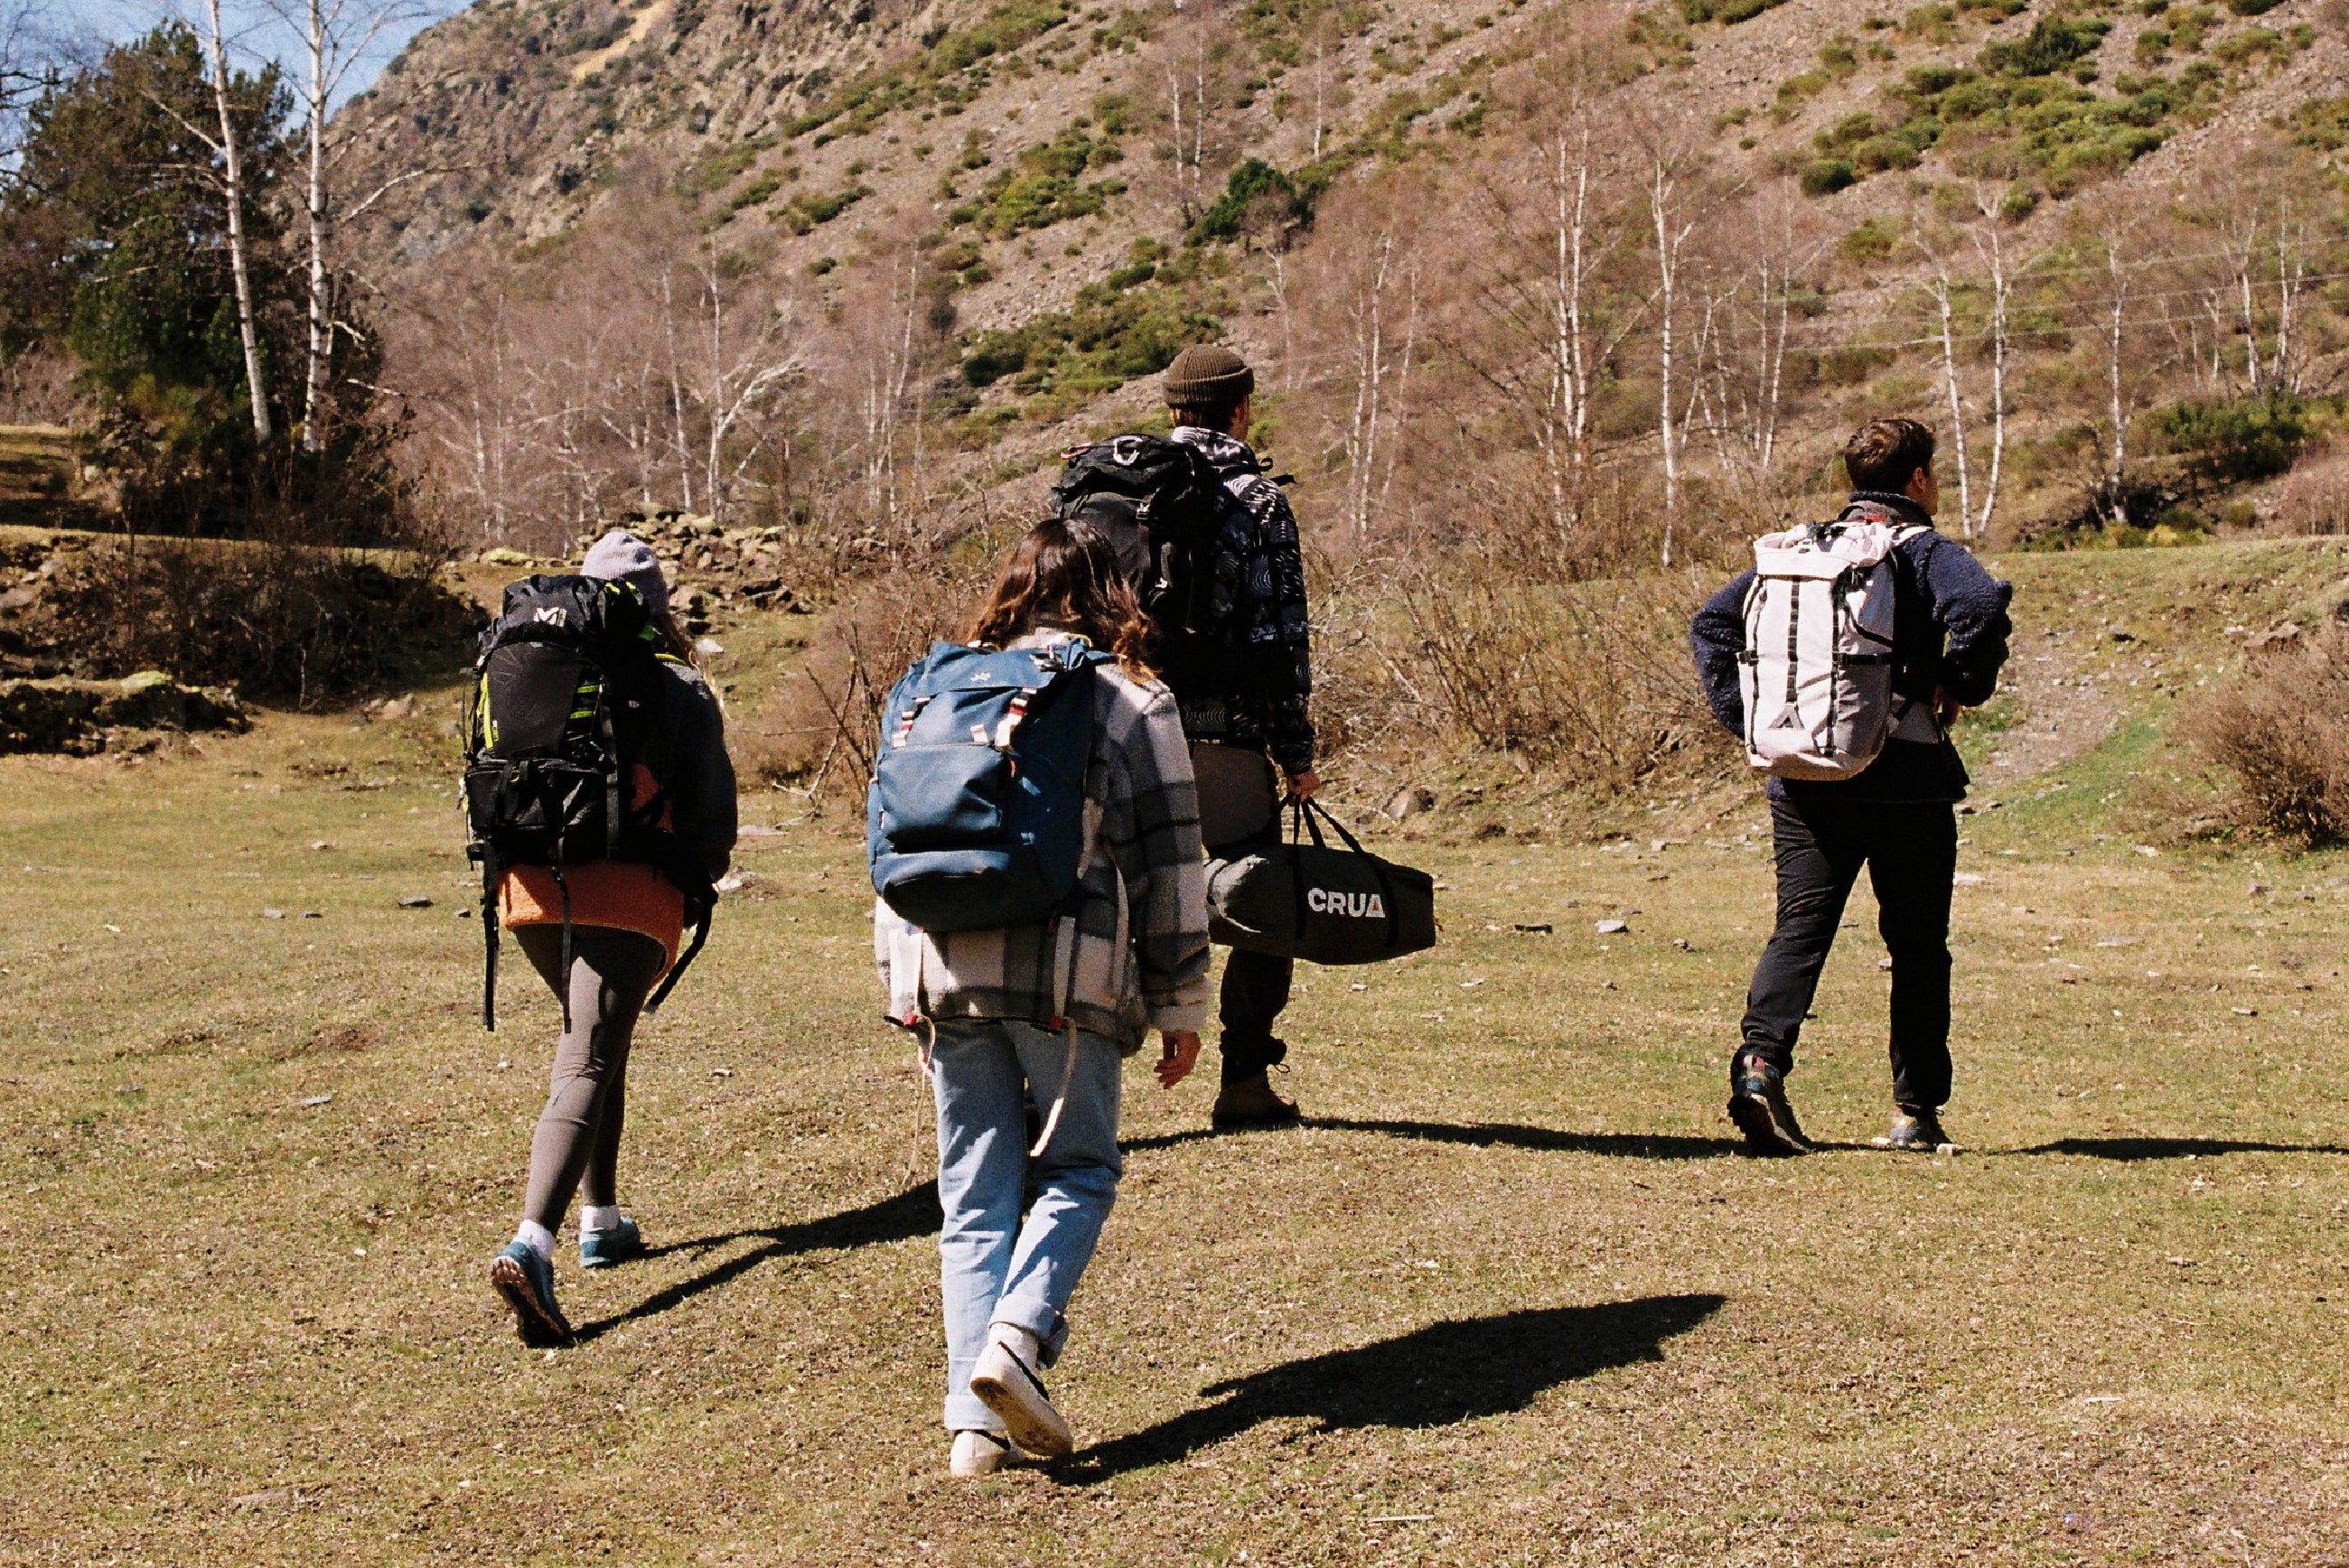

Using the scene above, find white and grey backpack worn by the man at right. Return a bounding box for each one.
[1738,518,1941,779]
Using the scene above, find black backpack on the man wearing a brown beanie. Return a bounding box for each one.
[1053,434,1238,686]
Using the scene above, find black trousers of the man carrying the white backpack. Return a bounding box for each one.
[1731,798,1957,1110]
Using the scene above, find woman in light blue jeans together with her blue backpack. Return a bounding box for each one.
[874,521,1207,1477]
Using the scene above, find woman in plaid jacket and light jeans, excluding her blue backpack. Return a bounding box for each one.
[874,521,1207,1477]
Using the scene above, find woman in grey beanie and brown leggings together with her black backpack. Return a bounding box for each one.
[467,530,735,1345]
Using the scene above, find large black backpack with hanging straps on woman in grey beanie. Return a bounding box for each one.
[463,577,716,1028]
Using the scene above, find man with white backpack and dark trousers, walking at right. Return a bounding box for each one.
[1691,418,2013,1155]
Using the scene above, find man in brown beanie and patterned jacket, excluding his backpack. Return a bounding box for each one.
[1165,342,1320,1129]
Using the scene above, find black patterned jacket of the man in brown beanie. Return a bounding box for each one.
[1172,425,1313,775]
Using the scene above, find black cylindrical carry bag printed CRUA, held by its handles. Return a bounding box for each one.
[1207,800,1436,965]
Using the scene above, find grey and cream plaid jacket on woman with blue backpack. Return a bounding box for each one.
[874,631,1207,1054]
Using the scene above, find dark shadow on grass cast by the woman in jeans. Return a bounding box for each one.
[1054,1296,1727,1486]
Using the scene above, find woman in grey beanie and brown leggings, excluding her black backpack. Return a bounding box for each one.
[484,530,735,1345]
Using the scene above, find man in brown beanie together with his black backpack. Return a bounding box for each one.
[1053,345,1320,1129]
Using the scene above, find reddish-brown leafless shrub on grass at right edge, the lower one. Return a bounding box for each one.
[2182,629,2349,845]
